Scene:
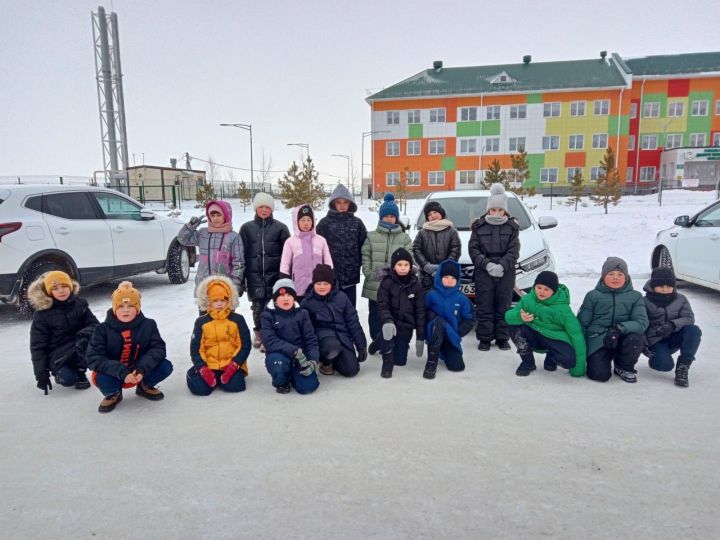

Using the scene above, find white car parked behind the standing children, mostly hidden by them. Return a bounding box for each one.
[408,190,558,297]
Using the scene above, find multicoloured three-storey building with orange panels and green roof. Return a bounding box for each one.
[367,51,720,192]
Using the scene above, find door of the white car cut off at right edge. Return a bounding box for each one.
[677,202,720,285]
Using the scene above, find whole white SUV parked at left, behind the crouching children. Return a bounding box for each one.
[0,185,196,316]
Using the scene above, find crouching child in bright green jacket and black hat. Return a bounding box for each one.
[505,270,585,377]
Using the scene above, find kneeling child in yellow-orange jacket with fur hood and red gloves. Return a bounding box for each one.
[186,276,252,396]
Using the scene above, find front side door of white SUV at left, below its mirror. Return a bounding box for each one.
[92,191,166,277]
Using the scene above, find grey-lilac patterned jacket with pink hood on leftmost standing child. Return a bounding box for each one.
[177,201,245,290]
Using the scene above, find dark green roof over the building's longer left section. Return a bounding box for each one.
[367,58,626,102]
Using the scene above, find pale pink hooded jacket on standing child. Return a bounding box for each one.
[280,205,332,296]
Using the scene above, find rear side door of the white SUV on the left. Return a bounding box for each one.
[41,191,115,283]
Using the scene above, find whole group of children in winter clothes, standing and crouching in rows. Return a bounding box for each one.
[29,185,701,412]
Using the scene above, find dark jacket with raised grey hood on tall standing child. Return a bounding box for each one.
[315,184,367,288]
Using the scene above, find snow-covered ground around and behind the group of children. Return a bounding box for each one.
[0,191,720,539]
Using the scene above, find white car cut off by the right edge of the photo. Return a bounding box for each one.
[650,201,720,291]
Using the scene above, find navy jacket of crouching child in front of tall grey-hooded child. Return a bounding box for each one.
[300,284,367,351]
